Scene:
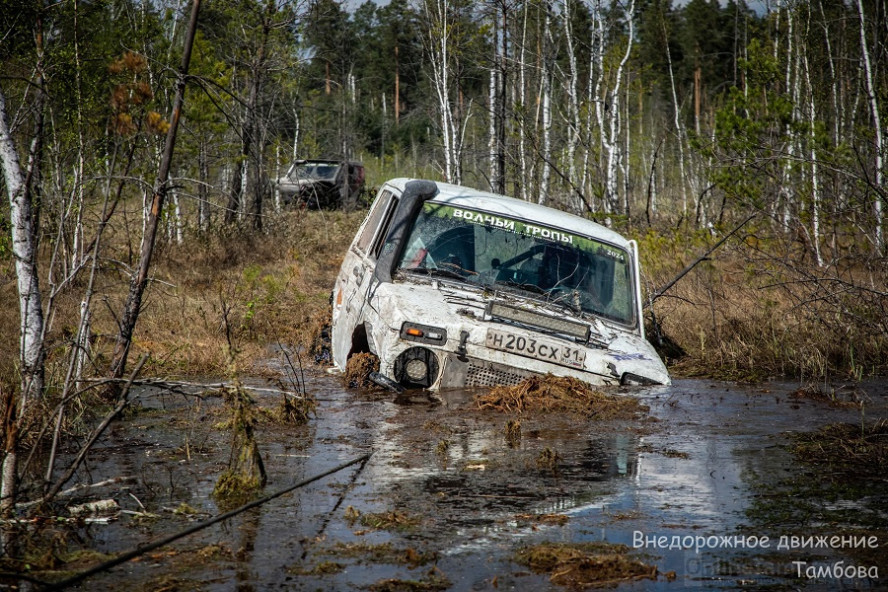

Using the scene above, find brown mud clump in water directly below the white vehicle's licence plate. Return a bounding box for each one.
[475,374,647,420]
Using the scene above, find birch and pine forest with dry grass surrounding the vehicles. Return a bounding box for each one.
[0,0,888,507]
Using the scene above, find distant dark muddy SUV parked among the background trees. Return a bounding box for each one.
[275,160,364,209]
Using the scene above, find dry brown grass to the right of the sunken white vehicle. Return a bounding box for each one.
[639,225,888,381]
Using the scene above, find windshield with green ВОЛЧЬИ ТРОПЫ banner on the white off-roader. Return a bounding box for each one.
[397,202,636,325]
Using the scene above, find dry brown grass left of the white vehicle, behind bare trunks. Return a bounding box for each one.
[13,207,364,384]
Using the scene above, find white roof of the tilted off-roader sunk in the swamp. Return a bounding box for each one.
[386,177,629,248]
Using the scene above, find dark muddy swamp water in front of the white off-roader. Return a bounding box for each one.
[15,372,888,591]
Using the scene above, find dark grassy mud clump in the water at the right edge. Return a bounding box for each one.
[792,419,888,480]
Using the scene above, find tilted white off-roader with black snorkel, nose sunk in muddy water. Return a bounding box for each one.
[332,179,669,390]
